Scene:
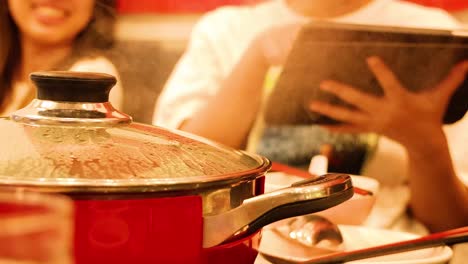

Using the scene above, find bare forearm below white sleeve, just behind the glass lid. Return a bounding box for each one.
[180,42,268,148]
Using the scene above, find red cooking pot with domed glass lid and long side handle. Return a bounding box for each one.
[0,72,353,264]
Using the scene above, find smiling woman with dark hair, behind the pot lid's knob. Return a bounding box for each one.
[0,0,122,116]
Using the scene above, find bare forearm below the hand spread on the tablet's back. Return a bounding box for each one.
[406,130,468,232]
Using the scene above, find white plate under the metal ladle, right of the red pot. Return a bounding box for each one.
[255,225,452,264]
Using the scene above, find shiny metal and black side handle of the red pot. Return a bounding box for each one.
[203,173,354,248]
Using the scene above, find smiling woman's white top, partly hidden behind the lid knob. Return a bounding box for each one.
[0,56,123,116]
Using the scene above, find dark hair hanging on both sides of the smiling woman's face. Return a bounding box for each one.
[0,0,116,111]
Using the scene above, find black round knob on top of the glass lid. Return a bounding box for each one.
[30,71,117,103]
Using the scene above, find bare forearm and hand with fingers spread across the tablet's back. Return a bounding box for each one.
[311,58,468,231]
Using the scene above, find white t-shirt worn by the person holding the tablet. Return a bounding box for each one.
[153,0,468,232]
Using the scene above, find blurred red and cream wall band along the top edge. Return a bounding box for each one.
[117,0,468,44]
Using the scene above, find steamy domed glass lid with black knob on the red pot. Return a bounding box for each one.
[0,72,270,191]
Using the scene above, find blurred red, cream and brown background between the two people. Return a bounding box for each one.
[110,0,468,123]
